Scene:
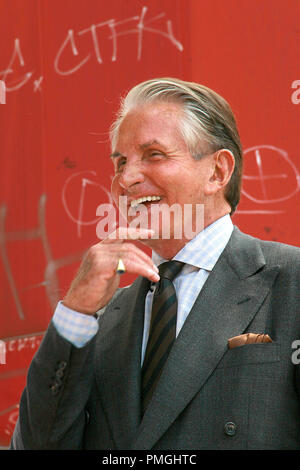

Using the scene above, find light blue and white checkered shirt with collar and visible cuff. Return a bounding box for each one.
[53,215,233,362]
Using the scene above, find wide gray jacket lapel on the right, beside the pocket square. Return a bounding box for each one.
[132,229,278,449]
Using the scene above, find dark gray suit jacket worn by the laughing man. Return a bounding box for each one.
[11,228,300,450]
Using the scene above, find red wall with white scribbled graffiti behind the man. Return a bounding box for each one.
[0,0,300,446]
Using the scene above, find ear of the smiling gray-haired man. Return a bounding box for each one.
[206,149,235,195]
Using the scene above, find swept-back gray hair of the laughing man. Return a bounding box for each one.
[110,78,243,214]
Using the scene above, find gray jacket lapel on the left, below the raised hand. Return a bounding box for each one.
[95,278,149,449]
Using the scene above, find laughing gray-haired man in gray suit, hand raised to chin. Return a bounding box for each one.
[11,78,300,449]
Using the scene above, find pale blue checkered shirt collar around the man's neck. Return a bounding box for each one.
[152,214,233,271]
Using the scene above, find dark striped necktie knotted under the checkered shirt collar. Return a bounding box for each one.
[142,261,184,414]
